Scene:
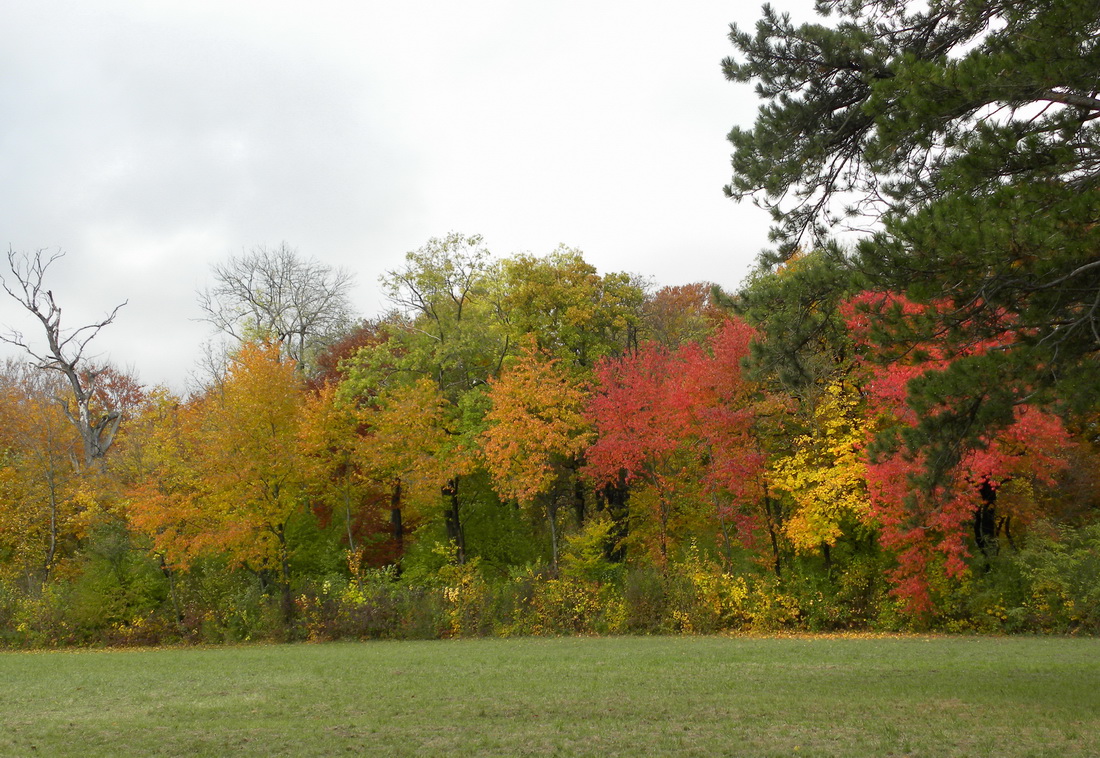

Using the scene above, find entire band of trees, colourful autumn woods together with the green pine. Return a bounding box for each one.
[0,0,1100,644]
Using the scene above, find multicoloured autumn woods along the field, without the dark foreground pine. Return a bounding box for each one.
[0,234,1100,642]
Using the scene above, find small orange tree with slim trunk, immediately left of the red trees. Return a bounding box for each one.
[481,338,592,568]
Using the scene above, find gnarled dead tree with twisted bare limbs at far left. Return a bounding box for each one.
[0,248,125,469]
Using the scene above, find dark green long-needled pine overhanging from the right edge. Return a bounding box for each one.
[724,0,1100,479]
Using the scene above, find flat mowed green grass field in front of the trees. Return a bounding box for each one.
[0,637,1100,757]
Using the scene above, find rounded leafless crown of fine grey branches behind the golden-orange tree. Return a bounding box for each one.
[199,242,353,371]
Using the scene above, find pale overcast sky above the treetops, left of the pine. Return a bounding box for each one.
[0,0,813,392]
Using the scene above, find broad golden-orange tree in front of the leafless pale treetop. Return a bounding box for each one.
[131,343,306,614]
